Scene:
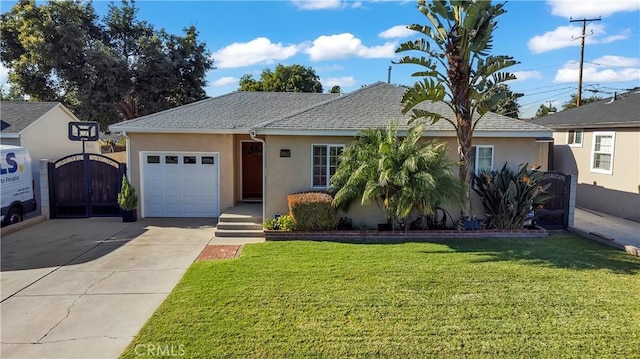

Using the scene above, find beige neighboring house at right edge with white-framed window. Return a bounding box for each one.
[533,88,640,221]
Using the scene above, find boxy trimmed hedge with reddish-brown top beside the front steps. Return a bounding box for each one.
[287,192,338,231]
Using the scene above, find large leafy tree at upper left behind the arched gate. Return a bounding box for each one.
[0,0,213,128]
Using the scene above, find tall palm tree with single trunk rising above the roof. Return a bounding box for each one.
[396,0,517,218]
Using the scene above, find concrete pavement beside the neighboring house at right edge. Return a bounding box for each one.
[569,208,640,256]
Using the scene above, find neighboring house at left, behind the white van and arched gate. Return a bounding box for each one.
[0,101,99,214]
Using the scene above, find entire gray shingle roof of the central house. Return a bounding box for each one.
[110,82,551,133]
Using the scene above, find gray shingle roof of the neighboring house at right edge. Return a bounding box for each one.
[531,88,640,129]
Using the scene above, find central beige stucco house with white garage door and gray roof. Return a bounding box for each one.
[110,83,552,224]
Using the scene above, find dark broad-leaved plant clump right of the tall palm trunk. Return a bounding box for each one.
[473,163,553,229]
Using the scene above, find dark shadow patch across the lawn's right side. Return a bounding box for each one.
[423,234,640,274]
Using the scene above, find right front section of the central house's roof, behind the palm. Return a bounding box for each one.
[258,82,550,132]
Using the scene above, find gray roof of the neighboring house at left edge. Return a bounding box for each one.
[0,101,59,133]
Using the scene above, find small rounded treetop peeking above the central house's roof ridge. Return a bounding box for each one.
[238,64,322,93]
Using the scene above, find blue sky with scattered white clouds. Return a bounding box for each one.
[0,0,640,118]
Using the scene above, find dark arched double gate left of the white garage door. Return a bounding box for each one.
[49,153,126,218]
